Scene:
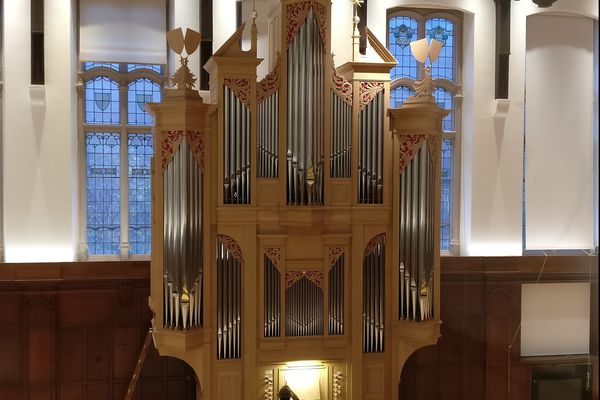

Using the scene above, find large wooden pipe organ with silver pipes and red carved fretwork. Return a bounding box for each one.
[149,0,445,400]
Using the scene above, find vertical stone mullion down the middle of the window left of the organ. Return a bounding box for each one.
[119,84,130,259]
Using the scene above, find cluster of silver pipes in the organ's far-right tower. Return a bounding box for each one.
[398,144,436,321]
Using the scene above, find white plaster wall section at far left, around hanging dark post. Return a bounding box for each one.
[2,0,78,262]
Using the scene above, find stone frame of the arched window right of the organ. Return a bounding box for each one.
[386,7,463,256]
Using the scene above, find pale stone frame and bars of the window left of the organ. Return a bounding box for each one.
[77,62,167,261]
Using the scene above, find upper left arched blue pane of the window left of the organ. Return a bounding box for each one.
[84,76,119,124]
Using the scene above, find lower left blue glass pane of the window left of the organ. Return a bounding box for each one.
[85,133,121,255]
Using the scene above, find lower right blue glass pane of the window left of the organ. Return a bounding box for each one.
[127,133,153,254]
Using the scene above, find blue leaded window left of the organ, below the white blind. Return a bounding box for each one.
[79,62,163,258]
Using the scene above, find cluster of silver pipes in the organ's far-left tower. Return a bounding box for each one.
[163,136,203,329]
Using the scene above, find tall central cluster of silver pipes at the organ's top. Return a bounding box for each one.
[286,10,324,205]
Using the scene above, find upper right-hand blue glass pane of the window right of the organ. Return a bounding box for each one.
[425,18,455,80]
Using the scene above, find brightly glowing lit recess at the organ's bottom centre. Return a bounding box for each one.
[283,360,324,400]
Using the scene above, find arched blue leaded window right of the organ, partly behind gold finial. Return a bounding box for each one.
[387,8,462,252]
